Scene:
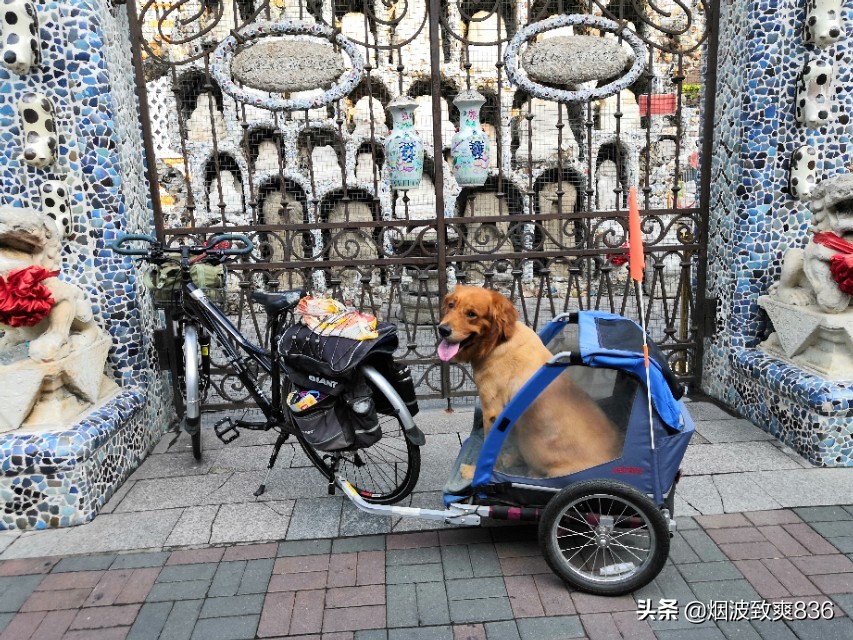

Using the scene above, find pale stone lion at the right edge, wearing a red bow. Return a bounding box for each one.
[769,174,853,313]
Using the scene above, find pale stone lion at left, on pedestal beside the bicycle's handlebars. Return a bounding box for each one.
[0,206,102,362]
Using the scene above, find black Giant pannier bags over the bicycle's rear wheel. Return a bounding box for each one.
[279,322,418,451]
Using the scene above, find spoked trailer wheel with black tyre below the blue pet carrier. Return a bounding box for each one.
[539,480,669,596]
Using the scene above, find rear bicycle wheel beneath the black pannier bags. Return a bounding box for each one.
[298,370,421,504]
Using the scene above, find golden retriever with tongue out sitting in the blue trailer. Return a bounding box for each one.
[438,286,624,477]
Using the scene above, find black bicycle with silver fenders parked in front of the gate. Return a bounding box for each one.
[109,234,424,504]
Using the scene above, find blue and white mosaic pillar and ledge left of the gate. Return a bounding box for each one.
[0,0,170,529]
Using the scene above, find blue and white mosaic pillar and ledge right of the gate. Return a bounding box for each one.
[704,0,853,466]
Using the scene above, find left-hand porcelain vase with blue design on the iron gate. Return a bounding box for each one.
[385,96,424,190]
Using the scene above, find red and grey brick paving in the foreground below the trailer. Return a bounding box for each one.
[0,506,853,640]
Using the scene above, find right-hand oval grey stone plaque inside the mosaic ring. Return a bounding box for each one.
[521,36,632,85]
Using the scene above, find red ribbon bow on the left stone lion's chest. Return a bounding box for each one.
[0,265,59,327]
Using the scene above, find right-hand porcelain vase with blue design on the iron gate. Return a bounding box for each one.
[450,90,490,187]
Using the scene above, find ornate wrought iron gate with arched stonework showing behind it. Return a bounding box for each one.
[129,0,716,406]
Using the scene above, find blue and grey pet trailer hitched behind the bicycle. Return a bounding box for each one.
[338,311,693,595]
